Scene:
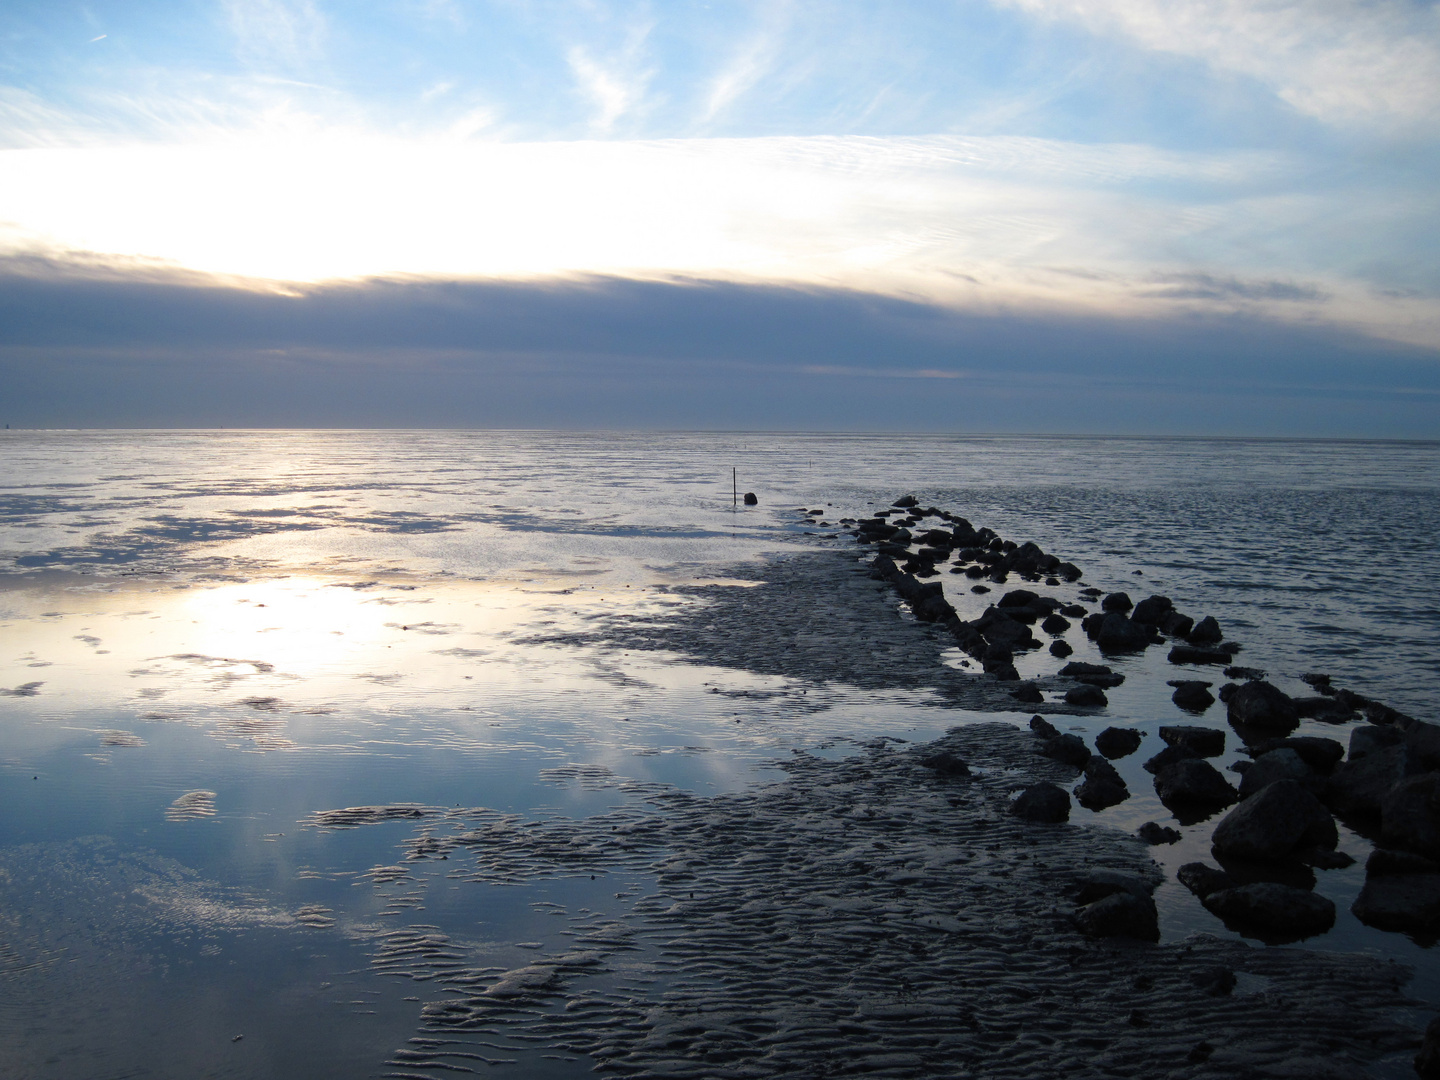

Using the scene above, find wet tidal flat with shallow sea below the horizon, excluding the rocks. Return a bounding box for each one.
[0,433,1440,1077]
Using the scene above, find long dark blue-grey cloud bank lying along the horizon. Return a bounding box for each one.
[0,261,1440,438]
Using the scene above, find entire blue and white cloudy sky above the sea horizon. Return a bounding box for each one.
[0,0,1440,438]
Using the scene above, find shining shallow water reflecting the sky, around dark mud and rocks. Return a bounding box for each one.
[0,432,1440,1077]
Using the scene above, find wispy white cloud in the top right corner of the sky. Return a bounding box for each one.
[999,0,1440,128]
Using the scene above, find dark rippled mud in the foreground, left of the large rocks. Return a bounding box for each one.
[347,724,1420,1080]
